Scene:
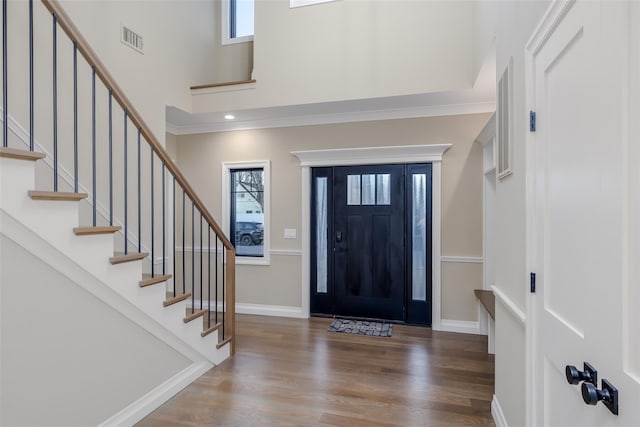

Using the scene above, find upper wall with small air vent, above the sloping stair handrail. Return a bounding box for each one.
[55,0,219,141]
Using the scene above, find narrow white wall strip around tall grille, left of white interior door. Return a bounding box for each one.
[473,1,549,426]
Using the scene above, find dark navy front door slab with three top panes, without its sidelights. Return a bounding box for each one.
[333,165,405,320]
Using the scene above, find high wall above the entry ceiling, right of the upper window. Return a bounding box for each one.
[193,0,475,112]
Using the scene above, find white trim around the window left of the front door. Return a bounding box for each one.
[220,160,271,265]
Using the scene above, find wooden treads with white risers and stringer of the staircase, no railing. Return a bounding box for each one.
[0,148,230,365]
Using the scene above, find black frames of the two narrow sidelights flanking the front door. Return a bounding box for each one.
[309,162,434,326]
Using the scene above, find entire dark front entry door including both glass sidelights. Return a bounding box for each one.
[311,164,431,325]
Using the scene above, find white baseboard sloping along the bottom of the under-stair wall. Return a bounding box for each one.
[100,362,213,427]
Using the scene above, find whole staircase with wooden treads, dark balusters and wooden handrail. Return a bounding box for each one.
[0,0,235,424]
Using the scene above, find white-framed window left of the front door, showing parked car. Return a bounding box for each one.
[222,161,270,264]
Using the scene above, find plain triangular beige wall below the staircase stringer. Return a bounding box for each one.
[0,235,191,427]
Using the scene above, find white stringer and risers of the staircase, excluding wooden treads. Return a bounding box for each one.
[0,158,230,365]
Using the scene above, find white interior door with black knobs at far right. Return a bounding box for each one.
[528,1,640,427]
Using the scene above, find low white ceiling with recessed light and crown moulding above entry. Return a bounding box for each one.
[167,50,496,135]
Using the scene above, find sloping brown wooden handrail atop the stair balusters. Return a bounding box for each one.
[41,0,235,252]
